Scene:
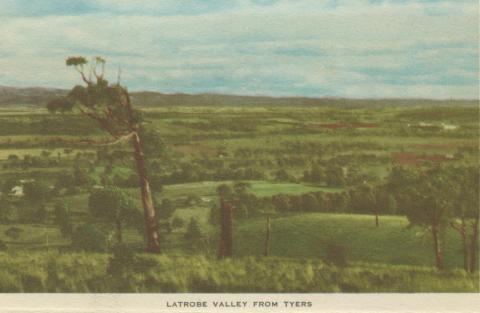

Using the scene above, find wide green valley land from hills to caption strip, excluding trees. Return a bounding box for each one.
[0,94,479,292]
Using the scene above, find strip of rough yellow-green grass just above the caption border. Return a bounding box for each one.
[0,252,479,293]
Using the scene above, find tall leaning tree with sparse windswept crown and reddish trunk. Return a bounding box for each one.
[47,56,160,252]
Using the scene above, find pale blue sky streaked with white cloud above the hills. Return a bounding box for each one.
[0,0,479,99]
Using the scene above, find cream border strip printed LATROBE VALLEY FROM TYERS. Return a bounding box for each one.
[0,293,480,313]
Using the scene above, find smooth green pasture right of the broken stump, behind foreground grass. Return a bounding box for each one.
[235,213,463,268]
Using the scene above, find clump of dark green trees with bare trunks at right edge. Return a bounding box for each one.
[388,167,480,272]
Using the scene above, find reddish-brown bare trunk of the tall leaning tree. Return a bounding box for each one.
[132,133,160,253]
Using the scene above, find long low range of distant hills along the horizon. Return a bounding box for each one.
[0,86,478,107]
